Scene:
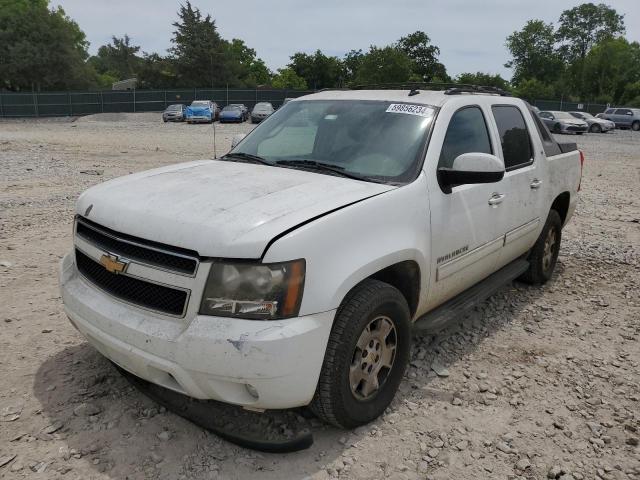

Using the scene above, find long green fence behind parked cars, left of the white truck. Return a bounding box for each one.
[0,88,313,117]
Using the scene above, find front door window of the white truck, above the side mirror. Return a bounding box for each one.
[438,107,493,168]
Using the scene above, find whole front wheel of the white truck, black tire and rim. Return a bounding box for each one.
[310,280,411,428]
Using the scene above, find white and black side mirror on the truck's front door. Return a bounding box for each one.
[438,152,504,193]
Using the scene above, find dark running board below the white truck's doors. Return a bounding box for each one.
[413,259,529,333]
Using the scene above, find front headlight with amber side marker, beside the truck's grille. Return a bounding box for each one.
[200,259,305,320]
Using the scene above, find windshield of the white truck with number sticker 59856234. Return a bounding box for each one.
[230,100,435,183]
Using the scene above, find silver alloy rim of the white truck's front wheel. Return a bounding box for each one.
[349,316,398,400]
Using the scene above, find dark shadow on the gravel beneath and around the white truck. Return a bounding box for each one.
[32,268,563,479]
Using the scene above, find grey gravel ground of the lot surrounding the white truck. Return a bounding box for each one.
[0,114,640,480]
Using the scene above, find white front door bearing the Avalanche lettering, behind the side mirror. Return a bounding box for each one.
[427,106,504,308]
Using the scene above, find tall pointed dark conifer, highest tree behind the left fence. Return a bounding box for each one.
[169,0,232,88]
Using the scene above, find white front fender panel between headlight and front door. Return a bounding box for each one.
[263,173,431,316]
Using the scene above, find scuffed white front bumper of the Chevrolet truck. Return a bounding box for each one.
[60,253,335,409]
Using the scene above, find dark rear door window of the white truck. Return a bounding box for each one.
[491,105,533,170]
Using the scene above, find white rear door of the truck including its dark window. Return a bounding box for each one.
[491,104,546,268]
